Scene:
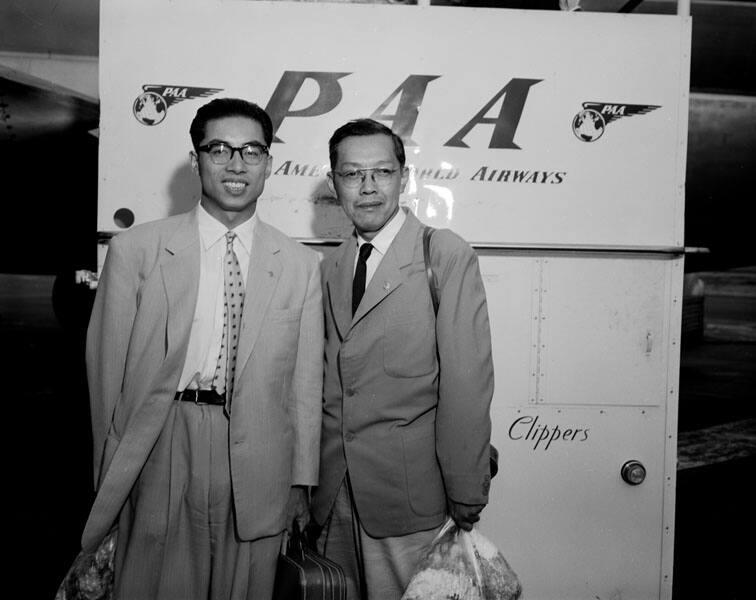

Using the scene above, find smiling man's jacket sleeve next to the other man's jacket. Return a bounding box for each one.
[289,256,323,486]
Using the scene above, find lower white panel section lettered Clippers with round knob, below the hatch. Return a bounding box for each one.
[479,406,665,600]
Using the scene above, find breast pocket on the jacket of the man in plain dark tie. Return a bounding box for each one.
[383,313,436,377]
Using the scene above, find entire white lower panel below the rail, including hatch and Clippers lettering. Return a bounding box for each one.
[480,250,683,600]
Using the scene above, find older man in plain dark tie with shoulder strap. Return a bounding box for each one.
[312,119,493,600]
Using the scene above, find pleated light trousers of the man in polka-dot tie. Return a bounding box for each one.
[114,401,281,600]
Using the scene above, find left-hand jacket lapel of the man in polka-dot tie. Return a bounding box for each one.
[160,211,200,360]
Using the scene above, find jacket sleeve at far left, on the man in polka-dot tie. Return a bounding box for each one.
[86,237,138,487]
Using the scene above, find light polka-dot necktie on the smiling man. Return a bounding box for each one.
[213,231,244,406]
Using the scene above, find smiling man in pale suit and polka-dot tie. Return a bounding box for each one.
[82,98,323,600]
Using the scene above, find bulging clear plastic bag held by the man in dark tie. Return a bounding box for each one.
[402,519,522,600]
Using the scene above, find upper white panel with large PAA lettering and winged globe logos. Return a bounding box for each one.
[98,0,690,247]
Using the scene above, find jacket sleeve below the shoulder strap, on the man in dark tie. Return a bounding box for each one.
[431,230,494,504]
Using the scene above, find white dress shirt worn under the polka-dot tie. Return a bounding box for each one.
[178,204,257,391]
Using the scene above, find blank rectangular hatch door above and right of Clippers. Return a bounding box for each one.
[538,256,671,406]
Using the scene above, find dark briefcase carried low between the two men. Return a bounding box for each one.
[273,521,346,600]
